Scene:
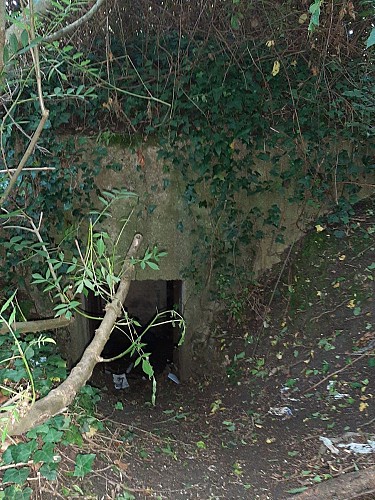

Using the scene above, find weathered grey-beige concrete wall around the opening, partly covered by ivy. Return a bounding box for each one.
[67,140,374,379]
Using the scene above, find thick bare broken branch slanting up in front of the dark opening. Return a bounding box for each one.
[0,234,142,435]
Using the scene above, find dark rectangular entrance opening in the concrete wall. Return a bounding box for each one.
[87,280,182,378]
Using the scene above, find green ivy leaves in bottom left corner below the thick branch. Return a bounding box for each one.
[0,386,103,500]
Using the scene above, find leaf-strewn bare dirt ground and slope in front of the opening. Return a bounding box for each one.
[43,200,375,500]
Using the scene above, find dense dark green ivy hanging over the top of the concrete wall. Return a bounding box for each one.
[3,2,374,292]
